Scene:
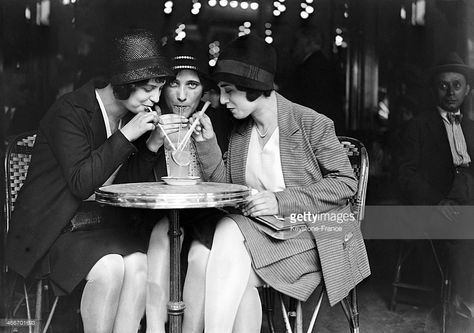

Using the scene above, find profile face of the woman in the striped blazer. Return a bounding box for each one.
[218,82,255,119]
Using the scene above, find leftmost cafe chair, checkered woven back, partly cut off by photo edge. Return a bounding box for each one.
[2,131,58,333]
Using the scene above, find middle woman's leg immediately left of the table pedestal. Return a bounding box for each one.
[146,218,170,333]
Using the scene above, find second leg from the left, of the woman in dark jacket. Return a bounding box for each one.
[114,252,147,333]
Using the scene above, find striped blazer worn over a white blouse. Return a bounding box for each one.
[197,93,370,305]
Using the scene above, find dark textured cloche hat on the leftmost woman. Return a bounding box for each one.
[109,29,173,85]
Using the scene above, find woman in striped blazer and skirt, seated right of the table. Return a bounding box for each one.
[189,35,370,333]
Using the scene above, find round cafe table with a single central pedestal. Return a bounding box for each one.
[95,182,250,333]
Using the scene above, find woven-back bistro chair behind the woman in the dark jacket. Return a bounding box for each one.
[2,132,58,333]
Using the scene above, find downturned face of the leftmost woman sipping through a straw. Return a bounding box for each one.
[123,77,166,113]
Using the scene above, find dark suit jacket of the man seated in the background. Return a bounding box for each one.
[398,108,474,205]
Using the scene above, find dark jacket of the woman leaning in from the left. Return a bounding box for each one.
[6,81,162,277]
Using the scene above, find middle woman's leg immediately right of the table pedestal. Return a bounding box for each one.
[183,241,210,333]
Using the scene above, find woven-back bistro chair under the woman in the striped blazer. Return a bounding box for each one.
[262,136,369,333]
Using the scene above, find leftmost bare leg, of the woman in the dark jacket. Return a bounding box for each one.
[81,254,124,333]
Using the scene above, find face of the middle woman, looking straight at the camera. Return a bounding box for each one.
[164,69,203,118]
